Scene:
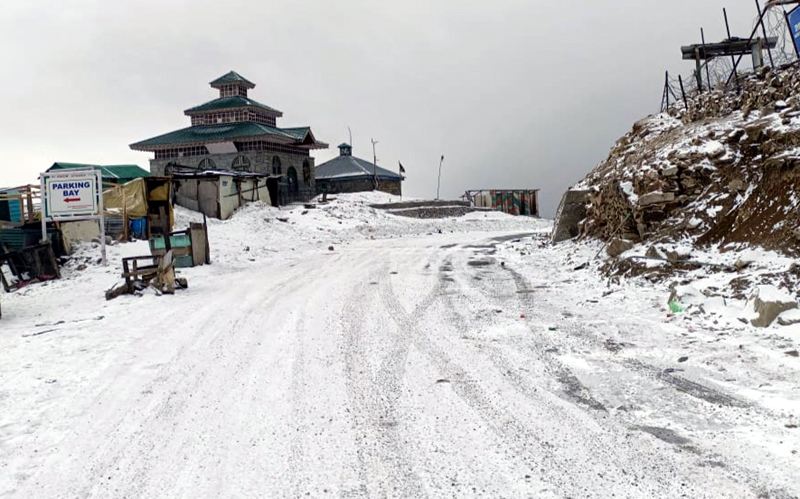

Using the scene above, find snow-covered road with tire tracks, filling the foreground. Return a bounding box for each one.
[0,229,800,498]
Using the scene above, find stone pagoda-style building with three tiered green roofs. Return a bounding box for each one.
[130,71,328,194]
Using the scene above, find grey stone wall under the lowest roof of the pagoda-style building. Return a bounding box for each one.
[150,151,316,192]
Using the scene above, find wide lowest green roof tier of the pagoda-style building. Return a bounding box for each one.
[131,121,297,151]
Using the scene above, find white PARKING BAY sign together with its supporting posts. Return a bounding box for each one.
[40,169,106,265]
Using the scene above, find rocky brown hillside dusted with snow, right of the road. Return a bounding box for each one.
[564,63,800,256]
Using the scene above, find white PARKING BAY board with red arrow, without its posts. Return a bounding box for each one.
[44,170,102,219]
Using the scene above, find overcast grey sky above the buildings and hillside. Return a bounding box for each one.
[0,0,776,216]
